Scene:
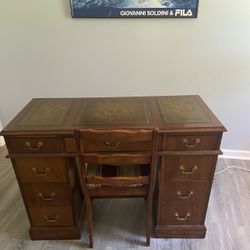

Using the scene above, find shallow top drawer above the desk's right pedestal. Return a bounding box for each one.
[163,134,218,151]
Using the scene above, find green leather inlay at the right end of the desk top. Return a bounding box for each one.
[157,96,209,123]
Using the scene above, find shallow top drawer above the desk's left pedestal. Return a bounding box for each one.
[8,137,64,153]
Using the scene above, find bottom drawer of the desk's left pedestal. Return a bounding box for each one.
[30,207,74,227]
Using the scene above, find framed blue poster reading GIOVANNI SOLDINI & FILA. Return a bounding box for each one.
[71,0,199,18]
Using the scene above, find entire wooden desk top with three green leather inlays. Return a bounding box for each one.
[1,95,226,135]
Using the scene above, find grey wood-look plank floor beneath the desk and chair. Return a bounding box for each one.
[0,147,250,250]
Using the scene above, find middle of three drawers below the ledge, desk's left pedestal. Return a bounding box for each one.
[22,183,71,206]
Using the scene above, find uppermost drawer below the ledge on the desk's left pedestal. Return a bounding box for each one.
[13,157,68,182]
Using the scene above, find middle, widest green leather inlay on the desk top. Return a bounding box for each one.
[75,98,150,125]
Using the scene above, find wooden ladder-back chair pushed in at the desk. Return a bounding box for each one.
[75,129,158,247]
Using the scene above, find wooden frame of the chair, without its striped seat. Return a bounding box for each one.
[75,129,158,247]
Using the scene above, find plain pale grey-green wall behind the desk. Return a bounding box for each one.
[0,0,250,150]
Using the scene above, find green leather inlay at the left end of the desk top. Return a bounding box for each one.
[18,99,73,126]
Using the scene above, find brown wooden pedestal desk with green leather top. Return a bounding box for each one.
[1,96,226,239]
